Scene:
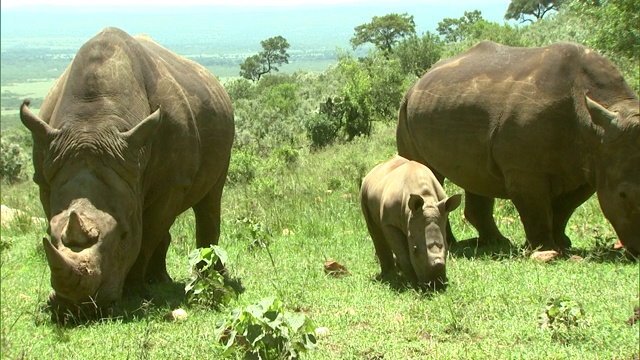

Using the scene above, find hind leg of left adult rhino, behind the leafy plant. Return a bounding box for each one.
[193,176,227,275]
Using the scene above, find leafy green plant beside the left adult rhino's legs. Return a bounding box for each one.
[184,245,235,308]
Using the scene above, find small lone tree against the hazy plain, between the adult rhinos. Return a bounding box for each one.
[240,36,290,81]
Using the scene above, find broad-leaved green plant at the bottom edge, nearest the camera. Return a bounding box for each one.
[214,297,316,359]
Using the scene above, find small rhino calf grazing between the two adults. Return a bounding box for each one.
[360,156,461,288]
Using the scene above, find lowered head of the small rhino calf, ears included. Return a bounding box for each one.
[407,194,462,289]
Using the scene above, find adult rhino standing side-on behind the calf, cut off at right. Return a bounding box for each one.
[397,41,640,252]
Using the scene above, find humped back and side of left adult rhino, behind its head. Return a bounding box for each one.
[34,28,234,216]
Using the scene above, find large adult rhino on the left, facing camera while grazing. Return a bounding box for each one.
[20,28,234,312]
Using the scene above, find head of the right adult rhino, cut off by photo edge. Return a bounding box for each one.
[586,97,640,256]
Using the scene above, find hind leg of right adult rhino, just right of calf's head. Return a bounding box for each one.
[464,191,509,244]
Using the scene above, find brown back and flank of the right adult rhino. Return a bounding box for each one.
[398,42,634,197]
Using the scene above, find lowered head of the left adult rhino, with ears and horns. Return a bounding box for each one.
[20,102,160,307]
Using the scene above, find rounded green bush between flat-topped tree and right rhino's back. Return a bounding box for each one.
[395,32,444,77]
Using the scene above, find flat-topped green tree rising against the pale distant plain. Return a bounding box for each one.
[351,13,416,54]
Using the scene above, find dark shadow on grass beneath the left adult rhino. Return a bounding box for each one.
[37,277,244,328]
